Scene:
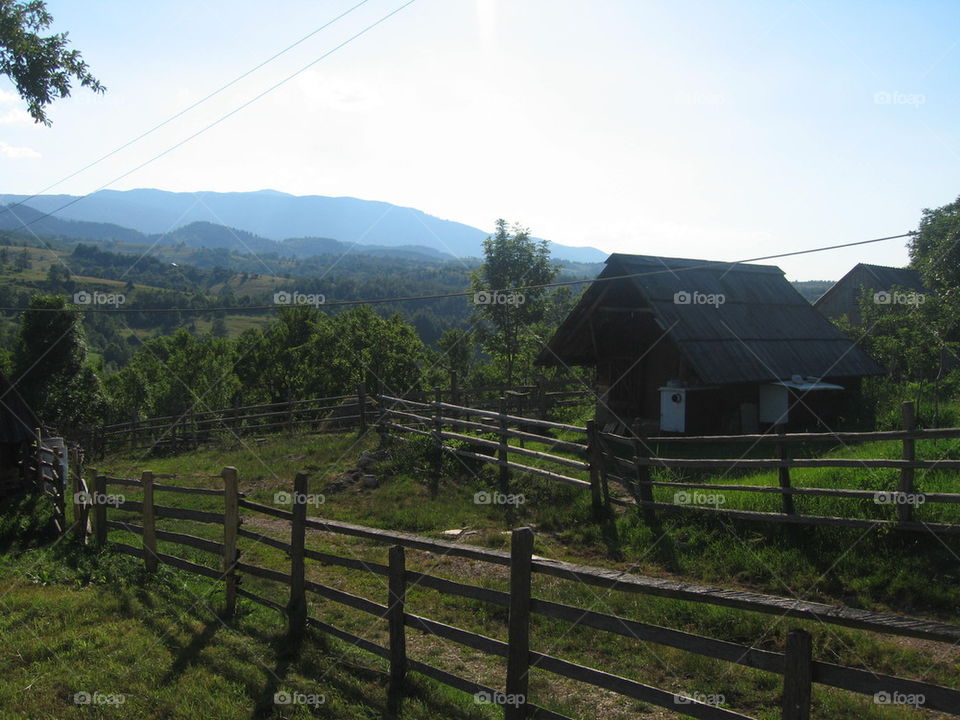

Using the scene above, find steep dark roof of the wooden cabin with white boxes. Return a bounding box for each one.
[537,253,883,384]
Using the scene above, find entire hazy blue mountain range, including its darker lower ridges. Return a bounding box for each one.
[0,189,607,262]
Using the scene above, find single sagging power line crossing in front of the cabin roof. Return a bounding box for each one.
[0,229,916,314]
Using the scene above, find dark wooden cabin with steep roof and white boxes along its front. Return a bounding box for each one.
[537,254,883,434]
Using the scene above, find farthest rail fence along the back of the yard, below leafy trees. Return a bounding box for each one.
[97,381,590,457]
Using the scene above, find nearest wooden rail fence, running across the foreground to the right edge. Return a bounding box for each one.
[84,467,960,720]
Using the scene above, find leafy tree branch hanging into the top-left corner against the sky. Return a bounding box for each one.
[0,0,106,125]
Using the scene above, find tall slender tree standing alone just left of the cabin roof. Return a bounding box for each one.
[470,219,559,384]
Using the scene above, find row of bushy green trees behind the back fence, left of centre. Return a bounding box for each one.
[106,306,426,421]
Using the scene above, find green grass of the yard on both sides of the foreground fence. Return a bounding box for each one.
[0,434,960,720]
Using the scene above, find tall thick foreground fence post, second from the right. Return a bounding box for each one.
[503,527,533,720]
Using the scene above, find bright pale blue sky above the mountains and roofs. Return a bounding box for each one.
[0,0,960,280]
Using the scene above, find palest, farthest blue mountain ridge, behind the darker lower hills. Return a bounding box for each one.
[0,189,606,262]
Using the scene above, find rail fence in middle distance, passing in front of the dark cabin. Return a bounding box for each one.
[378,396,960,533]
